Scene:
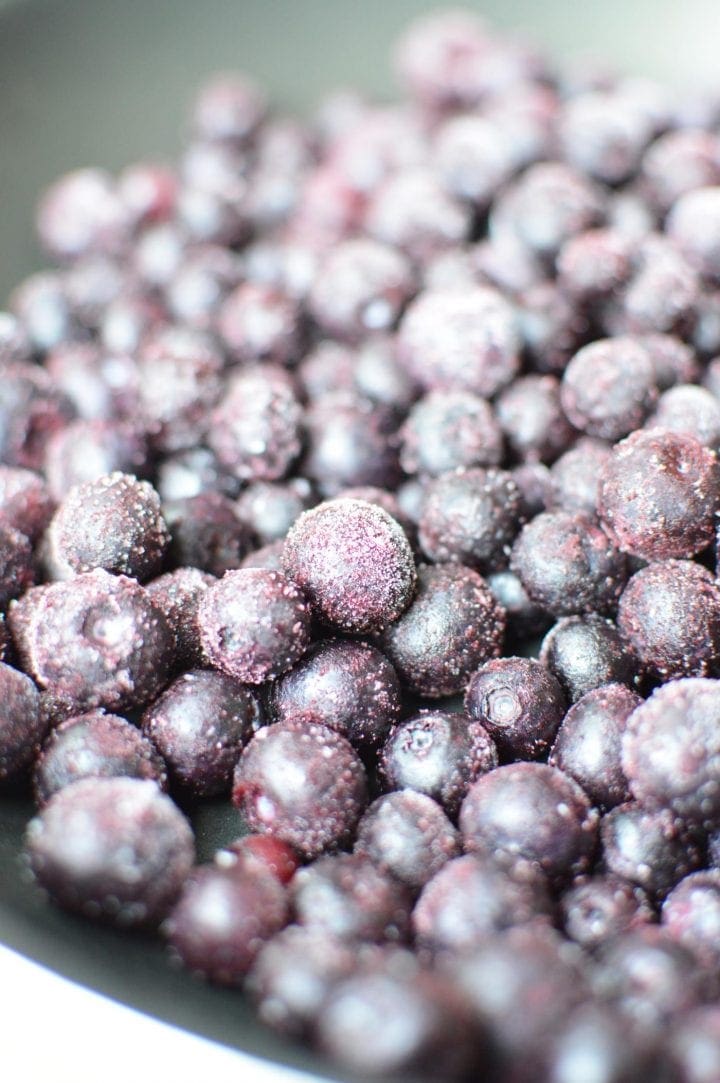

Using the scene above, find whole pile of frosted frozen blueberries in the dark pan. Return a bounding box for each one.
[5,4,720,1083]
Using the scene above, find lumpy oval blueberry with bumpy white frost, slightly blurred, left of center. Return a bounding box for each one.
[208,365,301,481]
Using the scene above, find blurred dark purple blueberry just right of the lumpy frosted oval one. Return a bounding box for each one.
[301,394,401,497]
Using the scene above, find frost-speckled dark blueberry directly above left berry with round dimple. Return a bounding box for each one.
[47,471,170,580]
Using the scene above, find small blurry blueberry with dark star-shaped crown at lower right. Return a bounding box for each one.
[560,873,656,951]
